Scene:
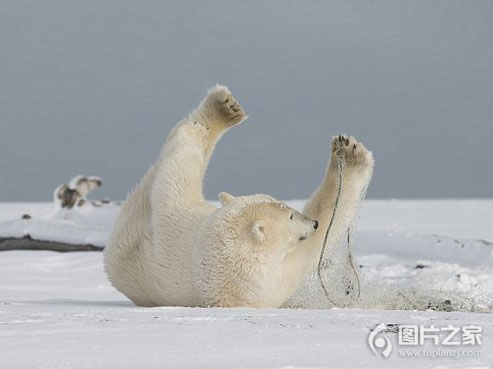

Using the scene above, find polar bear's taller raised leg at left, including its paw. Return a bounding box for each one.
[151,85,246,214]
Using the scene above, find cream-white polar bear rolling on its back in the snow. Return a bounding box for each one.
[104,85,373,308]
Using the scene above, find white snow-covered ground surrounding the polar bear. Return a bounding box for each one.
[0,200,493,368]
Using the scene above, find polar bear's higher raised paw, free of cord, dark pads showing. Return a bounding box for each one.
[202,85,247,127]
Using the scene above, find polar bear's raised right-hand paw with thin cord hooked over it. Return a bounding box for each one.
[332,135,373,168]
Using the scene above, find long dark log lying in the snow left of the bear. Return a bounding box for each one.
[0,237,103,252]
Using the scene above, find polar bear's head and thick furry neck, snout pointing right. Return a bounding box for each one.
[195,192,318,307]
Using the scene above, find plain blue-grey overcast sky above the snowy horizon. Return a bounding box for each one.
[0,0,493,201]
